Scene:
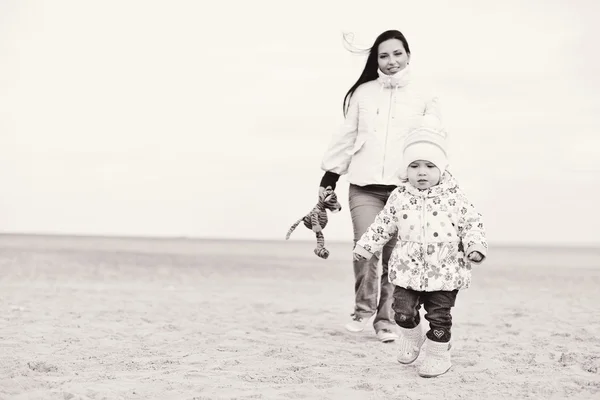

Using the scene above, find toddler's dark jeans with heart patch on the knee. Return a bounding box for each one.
[393,286,458,343]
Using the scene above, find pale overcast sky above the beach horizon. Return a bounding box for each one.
[0,0,600,244]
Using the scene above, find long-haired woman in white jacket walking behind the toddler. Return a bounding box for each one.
[319,30,441,342]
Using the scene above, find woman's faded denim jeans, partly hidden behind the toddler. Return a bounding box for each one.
[348,184,396,332]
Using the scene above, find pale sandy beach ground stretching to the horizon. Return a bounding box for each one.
[0,235,600,400]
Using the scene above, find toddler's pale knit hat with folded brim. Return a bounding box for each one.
[400,127,448,179]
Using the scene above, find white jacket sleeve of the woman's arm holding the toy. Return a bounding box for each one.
[321,87,360,175]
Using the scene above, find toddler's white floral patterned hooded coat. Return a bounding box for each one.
[354,172,488,292]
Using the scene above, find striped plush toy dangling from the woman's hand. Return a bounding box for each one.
[285,186,342,259]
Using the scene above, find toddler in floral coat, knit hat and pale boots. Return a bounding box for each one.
[354,128,488,377]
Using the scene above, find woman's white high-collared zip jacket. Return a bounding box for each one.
[321,66,442,186]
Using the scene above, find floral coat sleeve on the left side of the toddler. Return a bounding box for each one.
[354,189,401,258]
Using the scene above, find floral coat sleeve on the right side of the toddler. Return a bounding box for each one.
[458,193,488,261]
